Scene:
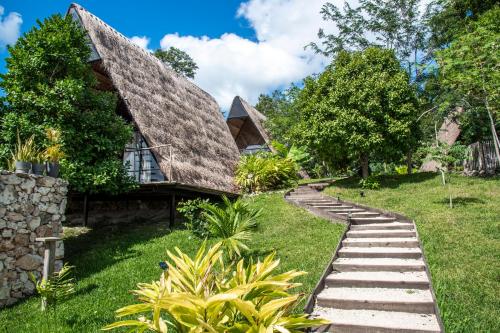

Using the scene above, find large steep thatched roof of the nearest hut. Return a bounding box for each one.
[70,4,239,192]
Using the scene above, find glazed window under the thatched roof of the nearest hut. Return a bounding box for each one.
[123,132,165,183]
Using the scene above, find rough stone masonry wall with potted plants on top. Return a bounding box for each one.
[0,171,68,307]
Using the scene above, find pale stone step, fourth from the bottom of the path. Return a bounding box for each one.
[332,258,425,272]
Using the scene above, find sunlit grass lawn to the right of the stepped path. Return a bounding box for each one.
[325,173,500,332]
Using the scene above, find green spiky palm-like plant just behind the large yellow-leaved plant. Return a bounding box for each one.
[202,196,262,259]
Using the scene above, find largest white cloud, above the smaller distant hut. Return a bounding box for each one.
[160,0,343,110]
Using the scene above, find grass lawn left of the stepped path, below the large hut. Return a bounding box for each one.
[0,193,344,333]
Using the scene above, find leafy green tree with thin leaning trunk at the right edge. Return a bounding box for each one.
[437,6,500,162]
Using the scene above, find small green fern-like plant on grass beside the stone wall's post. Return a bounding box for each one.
[31,264,75,311]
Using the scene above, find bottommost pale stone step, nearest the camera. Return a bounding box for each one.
[313,308,441,333]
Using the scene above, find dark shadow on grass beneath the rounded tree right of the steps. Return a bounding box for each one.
[332,172,437,191]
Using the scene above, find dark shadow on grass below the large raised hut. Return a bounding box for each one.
[64,219,181,282]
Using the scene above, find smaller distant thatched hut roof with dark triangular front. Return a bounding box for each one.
[227,96,271,149]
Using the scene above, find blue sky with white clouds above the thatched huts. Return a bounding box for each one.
[0,0,336,109]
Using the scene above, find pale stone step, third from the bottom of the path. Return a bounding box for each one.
[326,271,429,289]
